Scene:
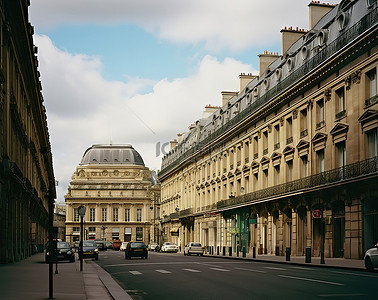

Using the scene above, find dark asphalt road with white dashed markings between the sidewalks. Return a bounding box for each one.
[96,251,378,300]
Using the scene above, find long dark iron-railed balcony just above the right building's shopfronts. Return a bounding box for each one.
[217,156,378,209]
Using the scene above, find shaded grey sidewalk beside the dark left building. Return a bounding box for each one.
[0,253,131,300]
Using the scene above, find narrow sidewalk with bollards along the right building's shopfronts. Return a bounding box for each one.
[204,253,365,270]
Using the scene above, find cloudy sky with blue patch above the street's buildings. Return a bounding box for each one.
[29,0,338,202]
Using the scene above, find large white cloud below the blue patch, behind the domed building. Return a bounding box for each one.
[35,35,253,201]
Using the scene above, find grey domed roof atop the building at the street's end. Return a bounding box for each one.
[80,144,144,166]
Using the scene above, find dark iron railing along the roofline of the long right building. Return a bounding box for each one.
[159,8,378,177]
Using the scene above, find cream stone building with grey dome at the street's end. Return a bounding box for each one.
[65,145,160,244]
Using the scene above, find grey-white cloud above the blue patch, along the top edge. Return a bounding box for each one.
[30,0,330,51]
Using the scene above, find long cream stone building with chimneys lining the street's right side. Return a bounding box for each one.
[159,0,378,258]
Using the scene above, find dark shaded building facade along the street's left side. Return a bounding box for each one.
[0,1,55,263]
